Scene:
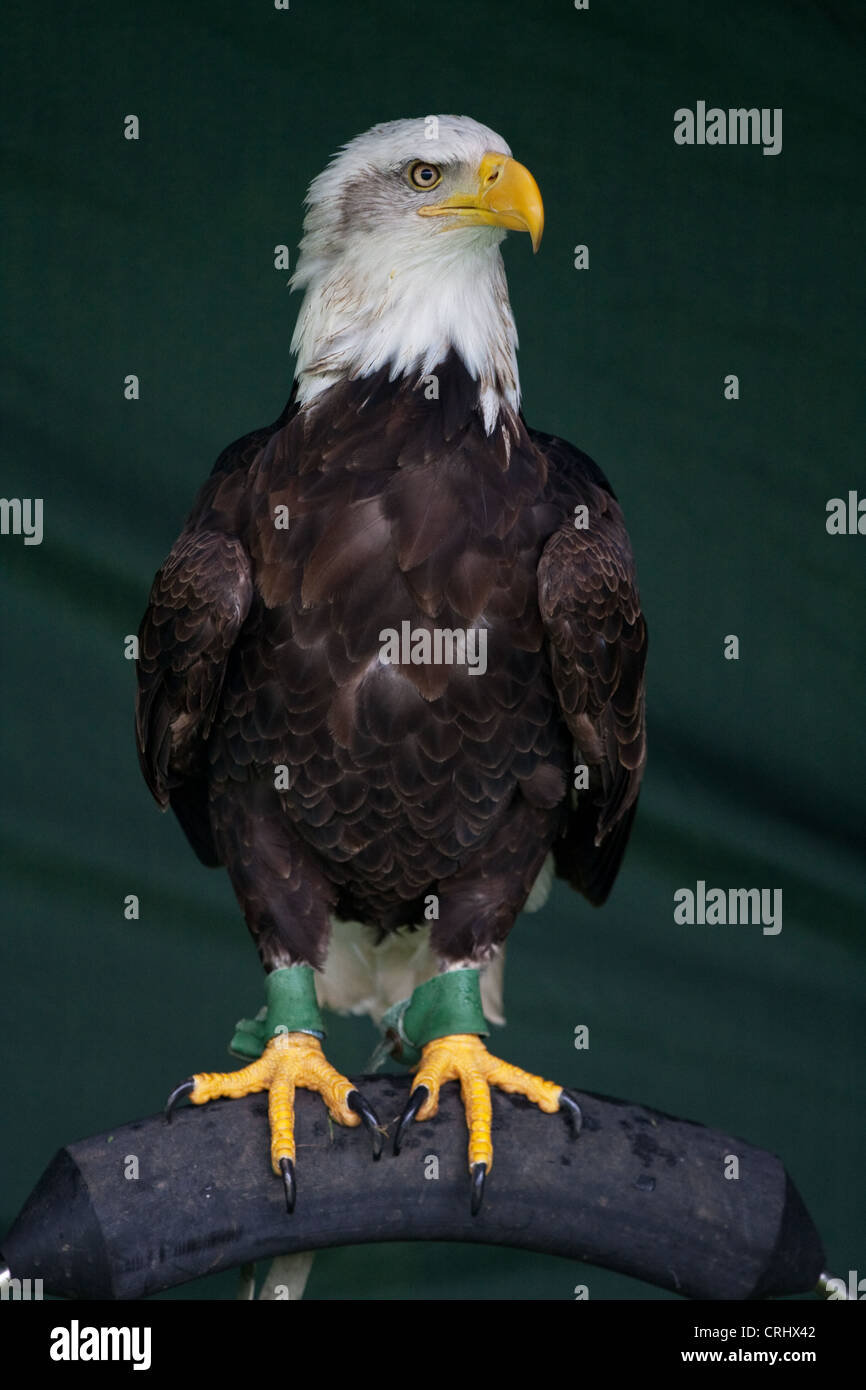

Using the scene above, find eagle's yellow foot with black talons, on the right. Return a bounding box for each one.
[393,1033,581,1216]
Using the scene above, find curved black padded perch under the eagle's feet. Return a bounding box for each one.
[0,1076,824,1298]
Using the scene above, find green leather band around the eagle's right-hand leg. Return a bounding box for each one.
[375,969,489,1066]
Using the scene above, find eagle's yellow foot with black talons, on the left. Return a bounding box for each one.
[165,1033,384,1212]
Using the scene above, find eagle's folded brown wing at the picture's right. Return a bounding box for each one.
[534,432,646,904]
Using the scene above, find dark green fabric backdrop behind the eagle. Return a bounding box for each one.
[0,0,866,1298]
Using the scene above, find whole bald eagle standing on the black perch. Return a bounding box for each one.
[136,115,646,1211]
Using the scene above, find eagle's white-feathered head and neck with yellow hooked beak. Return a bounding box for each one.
[292,115,544,434]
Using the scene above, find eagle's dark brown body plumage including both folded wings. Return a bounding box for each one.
[136,354,646,967]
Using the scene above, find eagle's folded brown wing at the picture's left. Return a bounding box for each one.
[135,530,253,865]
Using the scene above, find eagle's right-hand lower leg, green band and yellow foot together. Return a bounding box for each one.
[393,969,581,1215]
